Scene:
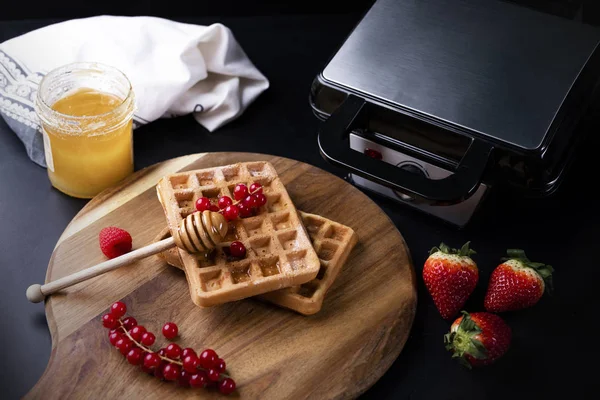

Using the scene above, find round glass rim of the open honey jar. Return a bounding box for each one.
[36,61,134,121]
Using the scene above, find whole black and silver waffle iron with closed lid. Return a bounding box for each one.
[310,0,600,227]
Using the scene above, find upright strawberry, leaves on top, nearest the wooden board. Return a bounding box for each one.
[423,242,479,319]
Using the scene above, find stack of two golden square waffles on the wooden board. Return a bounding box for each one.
[156,162,357,315]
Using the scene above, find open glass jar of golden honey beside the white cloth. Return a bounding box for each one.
[35,63,135,199]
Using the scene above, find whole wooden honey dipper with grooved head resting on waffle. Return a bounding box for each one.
[26,210,229,303]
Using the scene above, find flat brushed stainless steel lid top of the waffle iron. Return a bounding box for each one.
[323,0,600,149]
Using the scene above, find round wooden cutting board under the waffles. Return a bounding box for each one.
[26,153,417,400]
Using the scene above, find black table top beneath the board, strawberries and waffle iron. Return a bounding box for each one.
[0,9,600,399]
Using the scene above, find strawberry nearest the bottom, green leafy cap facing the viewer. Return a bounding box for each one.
[444,311,512,368]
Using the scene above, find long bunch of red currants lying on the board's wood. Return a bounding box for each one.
[102,302,236,394]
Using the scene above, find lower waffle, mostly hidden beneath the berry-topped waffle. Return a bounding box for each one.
[155,211,358,315]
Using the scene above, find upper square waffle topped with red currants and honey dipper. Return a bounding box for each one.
[156,162,320,307]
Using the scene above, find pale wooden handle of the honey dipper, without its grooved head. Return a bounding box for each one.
[26,237,175,303]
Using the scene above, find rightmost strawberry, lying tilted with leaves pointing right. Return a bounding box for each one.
[484,249,554,312]
